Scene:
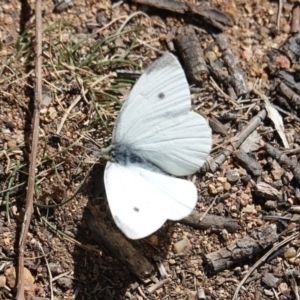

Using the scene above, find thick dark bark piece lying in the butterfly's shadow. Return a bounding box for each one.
[86,204,154,281]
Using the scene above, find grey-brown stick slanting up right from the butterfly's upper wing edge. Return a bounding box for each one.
[200,109,267,173]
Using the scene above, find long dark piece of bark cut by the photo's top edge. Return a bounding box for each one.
[131,0,229,30]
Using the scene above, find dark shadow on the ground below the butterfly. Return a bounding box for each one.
[72,165,178,300]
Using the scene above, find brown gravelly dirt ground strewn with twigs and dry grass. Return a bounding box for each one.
[0,0,300,300]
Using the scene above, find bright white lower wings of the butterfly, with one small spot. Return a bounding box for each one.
[104,162,197,239]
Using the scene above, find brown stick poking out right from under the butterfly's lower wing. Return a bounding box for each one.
[180,211,241,233]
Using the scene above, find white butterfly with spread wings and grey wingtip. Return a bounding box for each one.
[102,53,211,239]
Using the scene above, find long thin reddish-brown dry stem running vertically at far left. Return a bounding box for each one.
[16,0,42,300]
